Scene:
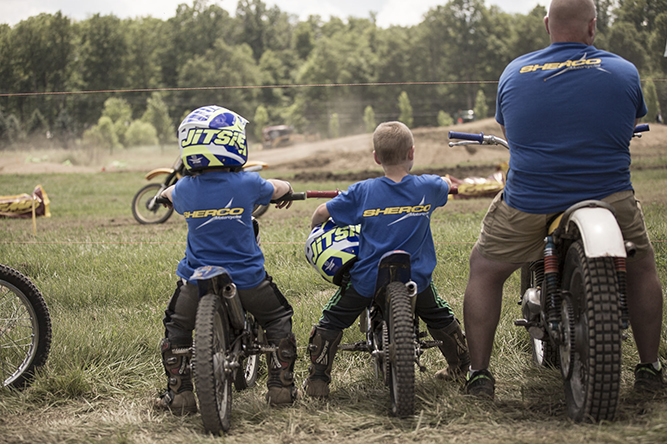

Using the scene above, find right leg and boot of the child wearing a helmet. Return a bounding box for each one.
[239,275,299,405]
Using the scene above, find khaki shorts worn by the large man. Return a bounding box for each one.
[476,190,651,264]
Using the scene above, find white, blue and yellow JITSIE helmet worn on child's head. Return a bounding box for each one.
[178,105,248,171]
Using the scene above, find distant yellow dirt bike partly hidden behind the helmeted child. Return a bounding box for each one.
[132,157,269,224]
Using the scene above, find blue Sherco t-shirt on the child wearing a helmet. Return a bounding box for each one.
[171,171,273,289]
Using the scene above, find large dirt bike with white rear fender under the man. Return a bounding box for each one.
[449,125,648,421]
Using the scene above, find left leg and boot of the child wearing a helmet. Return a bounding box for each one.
[155,281,199,415]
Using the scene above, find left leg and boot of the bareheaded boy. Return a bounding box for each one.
[304,285,372,398]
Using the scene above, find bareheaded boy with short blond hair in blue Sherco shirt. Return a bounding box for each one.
[305,122,470,398]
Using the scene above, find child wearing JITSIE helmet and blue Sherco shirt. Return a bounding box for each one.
[156,106,297,414]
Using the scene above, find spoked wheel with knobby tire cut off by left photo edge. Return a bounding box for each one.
[0,265,51,389]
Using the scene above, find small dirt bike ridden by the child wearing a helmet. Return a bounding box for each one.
[156,191,338,435]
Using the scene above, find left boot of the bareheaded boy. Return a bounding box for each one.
[304,326,343,398]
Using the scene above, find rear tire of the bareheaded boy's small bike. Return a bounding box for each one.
[387,282,415,418]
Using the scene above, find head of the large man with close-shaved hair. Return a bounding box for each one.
[544,0,596,45]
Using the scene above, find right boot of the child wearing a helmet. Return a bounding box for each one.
[266,334,299,406]
